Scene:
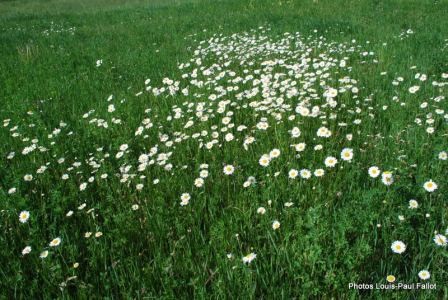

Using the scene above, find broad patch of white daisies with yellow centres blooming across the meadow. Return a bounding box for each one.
[3,27,448,286]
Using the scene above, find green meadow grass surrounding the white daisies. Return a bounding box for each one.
[0,0,448,299]
